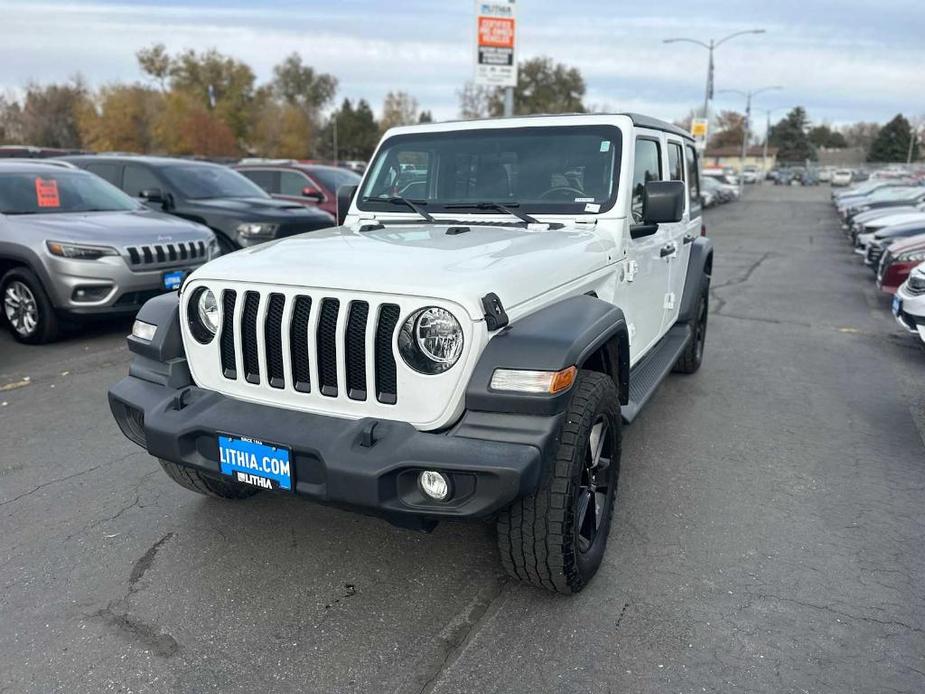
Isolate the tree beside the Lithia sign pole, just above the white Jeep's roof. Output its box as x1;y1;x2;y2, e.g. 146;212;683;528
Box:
488;57;586;116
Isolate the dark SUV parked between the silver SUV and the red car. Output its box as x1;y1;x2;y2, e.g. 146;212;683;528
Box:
64;155;334;253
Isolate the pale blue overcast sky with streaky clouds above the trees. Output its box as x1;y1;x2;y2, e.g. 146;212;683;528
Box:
0;0;925;130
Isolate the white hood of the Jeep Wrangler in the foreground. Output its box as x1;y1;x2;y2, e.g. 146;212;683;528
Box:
193;224;615;319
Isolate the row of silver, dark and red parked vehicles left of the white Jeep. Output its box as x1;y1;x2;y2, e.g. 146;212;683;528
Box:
0;155;360;344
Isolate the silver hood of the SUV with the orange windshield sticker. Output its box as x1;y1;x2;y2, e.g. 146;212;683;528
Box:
3;210;212;245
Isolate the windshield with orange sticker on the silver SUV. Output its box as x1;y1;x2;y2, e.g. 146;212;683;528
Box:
0;168;140;214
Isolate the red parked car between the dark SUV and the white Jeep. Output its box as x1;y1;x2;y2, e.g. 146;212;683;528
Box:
232;160;361;218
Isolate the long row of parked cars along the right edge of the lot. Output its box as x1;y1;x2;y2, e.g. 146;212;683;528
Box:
832;178;925;342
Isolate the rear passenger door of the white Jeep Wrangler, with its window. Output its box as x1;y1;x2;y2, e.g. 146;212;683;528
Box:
663;137;700;331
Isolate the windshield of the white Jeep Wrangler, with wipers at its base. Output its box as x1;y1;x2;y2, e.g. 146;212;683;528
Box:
357;125;621;214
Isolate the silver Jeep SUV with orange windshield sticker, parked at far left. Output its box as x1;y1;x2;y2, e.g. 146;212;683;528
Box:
0;162;217;344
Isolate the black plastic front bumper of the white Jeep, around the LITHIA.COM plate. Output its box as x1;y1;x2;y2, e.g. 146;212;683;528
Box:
109;378;561;524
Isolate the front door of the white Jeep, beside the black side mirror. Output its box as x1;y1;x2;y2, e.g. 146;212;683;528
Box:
622;132;668;363
